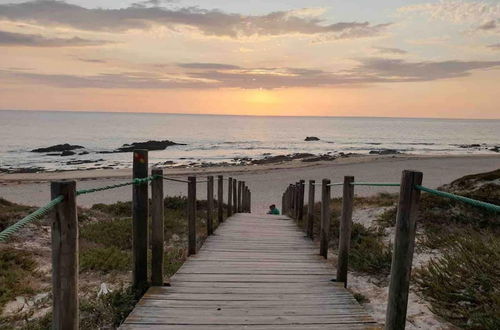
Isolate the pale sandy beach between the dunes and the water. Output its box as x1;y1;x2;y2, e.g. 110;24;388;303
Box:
0;155;500;213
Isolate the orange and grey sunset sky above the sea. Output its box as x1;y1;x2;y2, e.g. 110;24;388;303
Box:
0;0;500;119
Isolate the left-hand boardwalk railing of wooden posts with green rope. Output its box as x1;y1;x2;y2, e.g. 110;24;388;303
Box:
0;149;251;330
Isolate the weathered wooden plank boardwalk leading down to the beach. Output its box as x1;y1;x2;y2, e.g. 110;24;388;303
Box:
121;213;379;330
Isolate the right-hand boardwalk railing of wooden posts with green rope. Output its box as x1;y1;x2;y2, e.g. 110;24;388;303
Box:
282;170;500;330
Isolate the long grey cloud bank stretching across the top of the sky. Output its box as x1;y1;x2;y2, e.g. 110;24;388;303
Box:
0;0;389;39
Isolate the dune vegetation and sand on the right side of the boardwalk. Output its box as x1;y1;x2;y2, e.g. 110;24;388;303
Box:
299;169;500;329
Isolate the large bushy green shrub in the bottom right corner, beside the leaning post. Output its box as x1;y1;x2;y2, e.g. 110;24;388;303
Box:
414;232;500;329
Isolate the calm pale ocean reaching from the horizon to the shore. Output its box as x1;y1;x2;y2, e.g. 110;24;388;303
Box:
0;110;500;171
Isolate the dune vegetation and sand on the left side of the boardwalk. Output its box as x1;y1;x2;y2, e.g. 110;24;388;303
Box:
0;197;225;330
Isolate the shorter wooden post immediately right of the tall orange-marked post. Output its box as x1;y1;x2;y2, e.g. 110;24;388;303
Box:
151;168;165;286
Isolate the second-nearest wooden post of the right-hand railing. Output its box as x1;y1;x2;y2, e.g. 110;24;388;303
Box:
337;176;354;288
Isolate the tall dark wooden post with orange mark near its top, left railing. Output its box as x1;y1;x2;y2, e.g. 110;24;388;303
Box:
132;149;149;296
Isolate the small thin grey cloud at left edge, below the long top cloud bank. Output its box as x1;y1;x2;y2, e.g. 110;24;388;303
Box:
0;31;109;47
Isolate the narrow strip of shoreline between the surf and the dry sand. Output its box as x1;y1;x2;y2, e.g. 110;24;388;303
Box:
0;154;500;186
